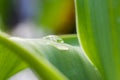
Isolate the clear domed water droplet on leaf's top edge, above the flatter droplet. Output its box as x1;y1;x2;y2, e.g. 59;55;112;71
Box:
43;35;64;43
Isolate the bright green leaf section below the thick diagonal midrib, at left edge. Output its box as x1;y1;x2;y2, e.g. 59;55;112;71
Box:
0;38;27;80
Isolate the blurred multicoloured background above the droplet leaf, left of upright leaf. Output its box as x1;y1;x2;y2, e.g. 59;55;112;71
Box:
0;0;76;38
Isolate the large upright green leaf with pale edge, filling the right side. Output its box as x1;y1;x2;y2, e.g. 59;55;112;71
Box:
76;0;120;80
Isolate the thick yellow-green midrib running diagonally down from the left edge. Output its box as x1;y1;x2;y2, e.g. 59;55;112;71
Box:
0;35;67;80
